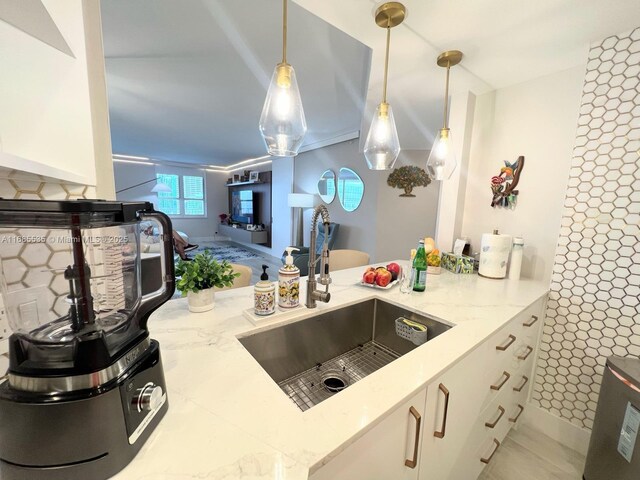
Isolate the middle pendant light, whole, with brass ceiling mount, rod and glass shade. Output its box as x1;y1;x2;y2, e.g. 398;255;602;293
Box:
364;2;406;170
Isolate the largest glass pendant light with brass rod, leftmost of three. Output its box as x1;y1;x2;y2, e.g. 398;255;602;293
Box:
259;0;307;157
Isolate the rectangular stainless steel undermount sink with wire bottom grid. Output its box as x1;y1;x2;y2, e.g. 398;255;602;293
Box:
238;299;451;411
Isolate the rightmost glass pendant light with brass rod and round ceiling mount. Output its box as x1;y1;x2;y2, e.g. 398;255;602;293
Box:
427;50;462;180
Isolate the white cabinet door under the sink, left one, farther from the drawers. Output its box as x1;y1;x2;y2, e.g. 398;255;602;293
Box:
311;390;426;480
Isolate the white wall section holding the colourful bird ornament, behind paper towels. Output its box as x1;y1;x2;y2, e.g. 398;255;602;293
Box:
461;66;584;281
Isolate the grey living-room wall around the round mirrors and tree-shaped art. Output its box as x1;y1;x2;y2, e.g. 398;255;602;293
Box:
294;139;438;263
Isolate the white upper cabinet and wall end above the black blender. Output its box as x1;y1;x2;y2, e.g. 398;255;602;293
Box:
0;0;113;191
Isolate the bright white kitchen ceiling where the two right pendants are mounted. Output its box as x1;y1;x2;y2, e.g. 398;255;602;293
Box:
293;0;640;149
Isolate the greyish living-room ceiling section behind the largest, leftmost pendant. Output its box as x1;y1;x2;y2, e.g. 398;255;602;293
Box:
101;0;371;165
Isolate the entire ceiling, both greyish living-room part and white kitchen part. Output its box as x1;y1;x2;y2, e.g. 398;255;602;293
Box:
102;0;640;165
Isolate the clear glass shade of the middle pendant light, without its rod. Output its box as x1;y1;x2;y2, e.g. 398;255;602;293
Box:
364;102;400;170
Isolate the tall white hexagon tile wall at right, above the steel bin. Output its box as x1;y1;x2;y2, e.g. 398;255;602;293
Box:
533;28;640;429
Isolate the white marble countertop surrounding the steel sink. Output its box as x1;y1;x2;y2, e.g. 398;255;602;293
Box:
113;262;548;480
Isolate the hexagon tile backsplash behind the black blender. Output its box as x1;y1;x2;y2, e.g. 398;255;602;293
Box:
0;167;95;322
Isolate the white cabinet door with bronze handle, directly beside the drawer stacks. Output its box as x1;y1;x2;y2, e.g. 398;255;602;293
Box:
419;342;489;480
